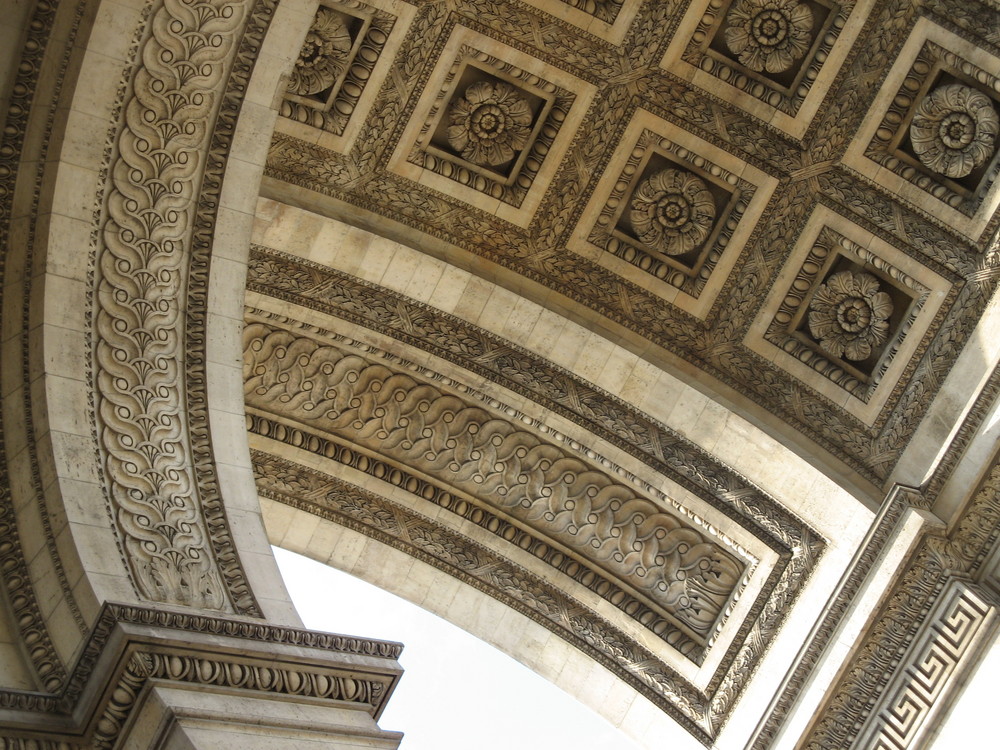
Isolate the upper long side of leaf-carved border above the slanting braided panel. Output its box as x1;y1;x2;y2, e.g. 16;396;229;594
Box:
242;247;824;576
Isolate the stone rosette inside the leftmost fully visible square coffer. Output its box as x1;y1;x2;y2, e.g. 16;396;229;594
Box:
448;81;531;167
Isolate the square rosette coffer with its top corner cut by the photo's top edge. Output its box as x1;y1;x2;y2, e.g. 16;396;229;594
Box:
661;0;871;137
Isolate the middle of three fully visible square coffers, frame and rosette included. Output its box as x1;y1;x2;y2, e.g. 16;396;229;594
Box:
569;110;777;317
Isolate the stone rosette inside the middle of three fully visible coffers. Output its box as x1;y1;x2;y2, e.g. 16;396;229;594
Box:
629;169;715;255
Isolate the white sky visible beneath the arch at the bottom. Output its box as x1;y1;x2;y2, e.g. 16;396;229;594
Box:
274;548;639;750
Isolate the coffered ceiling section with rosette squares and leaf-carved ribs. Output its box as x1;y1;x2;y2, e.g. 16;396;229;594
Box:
265;0;1000;495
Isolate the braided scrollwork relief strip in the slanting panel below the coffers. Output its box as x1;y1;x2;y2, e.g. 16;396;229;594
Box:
244;323;746;639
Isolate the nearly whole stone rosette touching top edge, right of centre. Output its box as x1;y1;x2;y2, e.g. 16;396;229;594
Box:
725;0;813;73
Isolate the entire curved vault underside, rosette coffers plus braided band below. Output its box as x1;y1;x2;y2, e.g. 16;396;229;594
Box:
244;0;1000;744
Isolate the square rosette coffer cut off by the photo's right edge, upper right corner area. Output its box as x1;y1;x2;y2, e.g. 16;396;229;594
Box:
844;19;1000;240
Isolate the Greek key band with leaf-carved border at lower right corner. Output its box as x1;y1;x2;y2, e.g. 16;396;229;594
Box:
801;456;1000;750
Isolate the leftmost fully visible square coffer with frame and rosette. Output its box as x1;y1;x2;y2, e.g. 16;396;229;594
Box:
389;26;595;226
